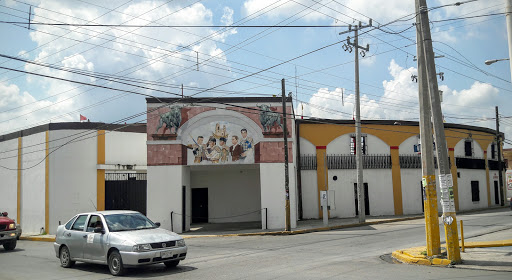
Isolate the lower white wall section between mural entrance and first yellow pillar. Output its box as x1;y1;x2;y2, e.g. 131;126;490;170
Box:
301;170;320;219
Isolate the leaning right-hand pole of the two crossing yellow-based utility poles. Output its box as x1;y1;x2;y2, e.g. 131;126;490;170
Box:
417;0;461;263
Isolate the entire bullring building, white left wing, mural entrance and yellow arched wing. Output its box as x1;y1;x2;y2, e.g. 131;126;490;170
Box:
0;97;512;234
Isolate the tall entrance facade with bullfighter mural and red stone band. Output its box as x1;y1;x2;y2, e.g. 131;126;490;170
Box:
147;97;297;232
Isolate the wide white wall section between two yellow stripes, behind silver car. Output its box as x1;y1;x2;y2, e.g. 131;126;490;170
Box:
49;130;98;234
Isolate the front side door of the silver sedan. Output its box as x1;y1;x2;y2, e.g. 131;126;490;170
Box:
83;215;107;261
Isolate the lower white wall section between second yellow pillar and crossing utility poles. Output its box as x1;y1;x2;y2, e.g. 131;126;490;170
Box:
400;168;423;215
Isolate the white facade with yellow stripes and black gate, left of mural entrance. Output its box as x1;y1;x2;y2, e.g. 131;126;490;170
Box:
0;123;146;234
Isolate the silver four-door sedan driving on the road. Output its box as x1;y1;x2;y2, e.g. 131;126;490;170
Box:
53;210;187;276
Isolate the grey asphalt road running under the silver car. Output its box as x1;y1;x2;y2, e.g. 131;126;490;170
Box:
0;209;512;280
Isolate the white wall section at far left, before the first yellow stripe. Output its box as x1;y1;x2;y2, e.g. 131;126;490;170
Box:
0;138;18;224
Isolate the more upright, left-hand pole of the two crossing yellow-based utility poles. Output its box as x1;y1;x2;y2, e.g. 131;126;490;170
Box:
416;1;441;257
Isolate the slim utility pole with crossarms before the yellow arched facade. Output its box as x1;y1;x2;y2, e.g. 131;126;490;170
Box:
340;19;372;223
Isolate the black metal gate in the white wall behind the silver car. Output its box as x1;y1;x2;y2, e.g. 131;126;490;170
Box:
105;173;147;215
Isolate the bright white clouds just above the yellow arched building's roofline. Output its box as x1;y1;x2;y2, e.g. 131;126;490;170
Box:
297;60;504;135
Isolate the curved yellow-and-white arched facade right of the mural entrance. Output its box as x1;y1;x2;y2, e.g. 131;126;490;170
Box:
297;119;505;219
